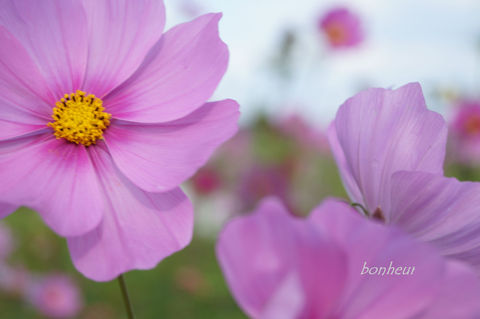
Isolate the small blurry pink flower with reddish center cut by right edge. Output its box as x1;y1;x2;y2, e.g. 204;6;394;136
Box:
449;101;480;165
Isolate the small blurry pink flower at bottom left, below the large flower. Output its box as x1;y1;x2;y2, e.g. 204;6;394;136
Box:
28;275;83;318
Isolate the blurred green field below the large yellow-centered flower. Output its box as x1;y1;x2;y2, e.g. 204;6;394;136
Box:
0;208;246;319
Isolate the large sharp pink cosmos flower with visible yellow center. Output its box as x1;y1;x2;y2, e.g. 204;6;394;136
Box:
0;0;239;281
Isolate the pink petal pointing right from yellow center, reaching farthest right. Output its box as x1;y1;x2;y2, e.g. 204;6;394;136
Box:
105;100;239;192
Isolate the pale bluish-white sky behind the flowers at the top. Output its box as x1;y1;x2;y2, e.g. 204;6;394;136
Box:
165;0;480;124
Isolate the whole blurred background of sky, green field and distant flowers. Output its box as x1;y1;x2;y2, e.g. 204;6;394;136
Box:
0;0;480;319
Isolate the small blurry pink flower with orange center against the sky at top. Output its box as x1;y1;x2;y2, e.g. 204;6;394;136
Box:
318;7;364;49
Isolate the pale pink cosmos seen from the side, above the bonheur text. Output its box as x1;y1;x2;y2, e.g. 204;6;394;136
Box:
329;83;480;270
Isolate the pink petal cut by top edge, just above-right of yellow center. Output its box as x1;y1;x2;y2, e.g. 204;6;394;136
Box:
82;0;165;97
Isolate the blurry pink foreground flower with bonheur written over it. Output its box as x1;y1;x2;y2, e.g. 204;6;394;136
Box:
217;199;480;319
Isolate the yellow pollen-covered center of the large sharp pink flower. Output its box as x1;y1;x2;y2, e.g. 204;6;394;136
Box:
48;91;112;146
